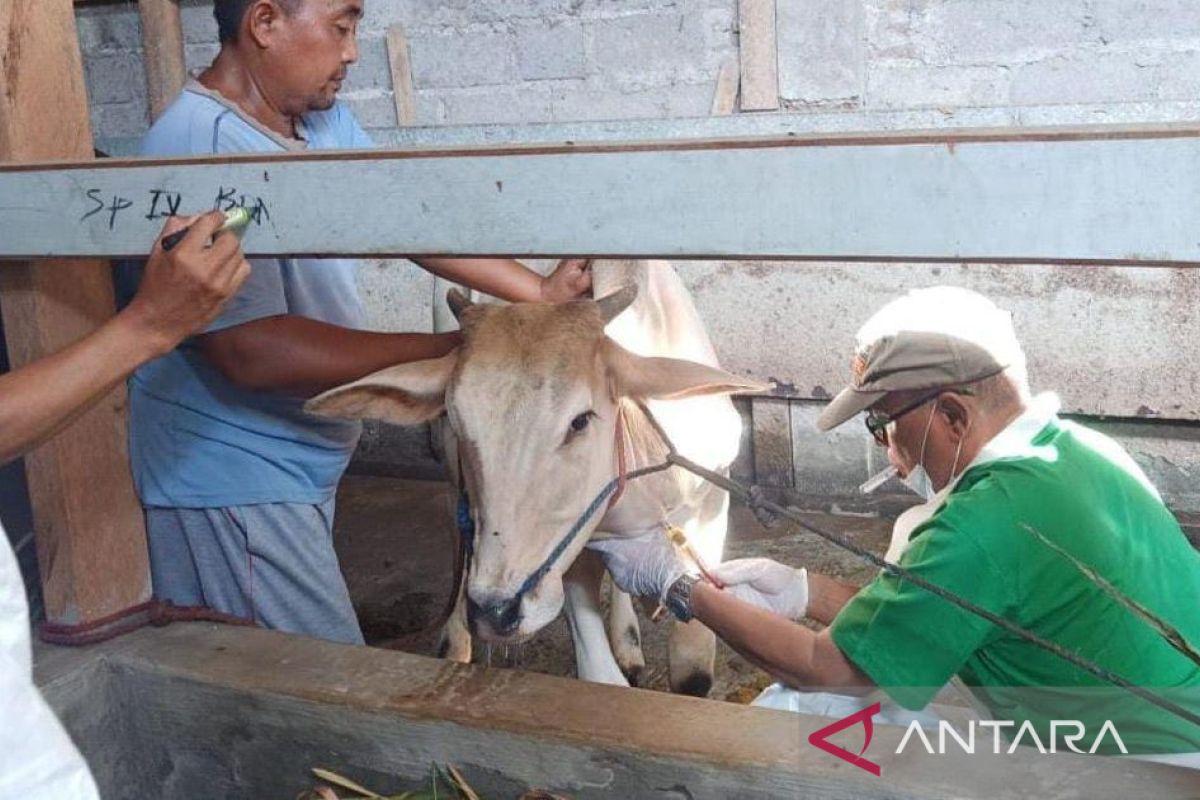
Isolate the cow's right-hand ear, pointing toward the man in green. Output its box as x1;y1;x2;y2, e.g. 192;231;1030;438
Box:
601;337;770;399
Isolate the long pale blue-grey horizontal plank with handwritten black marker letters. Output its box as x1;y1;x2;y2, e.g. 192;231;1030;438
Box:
0;127;1200;265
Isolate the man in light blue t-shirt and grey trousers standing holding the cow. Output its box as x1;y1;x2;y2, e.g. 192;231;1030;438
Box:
130;0;590;643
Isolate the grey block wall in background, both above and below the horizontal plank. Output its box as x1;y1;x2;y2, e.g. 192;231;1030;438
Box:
78;0;1200;520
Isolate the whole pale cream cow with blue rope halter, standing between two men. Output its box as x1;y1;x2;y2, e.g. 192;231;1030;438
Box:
306;260;766;696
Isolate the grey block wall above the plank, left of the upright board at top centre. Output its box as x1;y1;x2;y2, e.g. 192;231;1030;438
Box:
77;0;737;137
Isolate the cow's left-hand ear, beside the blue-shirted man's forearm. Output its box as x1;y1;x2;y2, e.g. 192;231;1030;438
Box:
304;350;458;425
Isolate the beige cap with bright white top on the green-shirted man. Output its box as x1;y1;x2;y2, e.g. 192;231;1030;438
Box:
817;287;1025;431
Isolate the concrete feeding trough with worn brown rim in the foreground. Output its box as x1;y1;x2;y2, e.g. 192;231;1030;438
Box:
37;624;1200;800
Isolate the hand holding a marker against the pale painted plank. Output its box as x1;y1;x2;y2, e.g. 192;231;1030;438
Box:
122;211;250;353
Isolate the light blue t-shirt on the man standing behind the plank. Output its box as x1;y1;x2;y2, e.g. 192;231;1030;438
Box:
130;82;371;507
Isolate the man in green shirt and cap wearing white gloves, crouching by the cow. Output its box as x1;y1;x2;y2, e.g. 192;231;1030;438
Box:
594;288;1200;765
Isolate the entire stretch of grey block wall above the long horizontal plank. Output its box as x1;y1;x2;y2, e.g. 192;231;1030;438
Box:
77;0;1200;137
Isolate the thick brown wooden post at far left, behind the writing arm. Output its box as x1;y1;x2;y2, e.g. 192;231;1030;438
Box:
0;0;150;624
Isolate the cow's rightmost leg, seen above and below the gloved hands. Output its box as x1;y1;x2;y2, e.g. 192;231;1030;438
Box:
667;488;730;697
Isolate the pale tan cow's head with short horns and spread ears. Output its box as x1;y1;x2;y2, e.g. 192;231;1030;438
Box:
306;287;761;640
